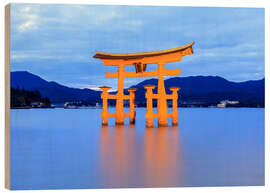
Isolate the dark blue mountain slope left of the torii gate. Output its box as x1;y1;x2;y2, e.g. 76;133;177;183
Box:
10;71;101;104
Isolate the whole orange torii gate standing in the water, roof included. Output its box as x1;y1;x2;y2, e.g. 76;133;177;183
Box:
94;42;194;127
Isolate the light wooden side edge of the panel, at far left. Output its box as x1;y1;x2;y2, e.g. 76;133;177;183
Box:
5;4;10;189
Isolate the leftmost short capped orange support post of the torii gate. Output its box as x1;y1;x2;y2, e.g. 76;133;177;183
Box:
99;86;111;125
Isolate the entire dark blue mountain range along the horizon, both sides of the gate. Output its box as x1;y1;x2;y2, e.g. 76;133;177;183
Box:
11;71;265;106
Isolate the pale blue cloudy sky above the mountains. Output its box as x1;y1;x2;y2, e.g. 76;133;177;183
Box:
10;4;265;89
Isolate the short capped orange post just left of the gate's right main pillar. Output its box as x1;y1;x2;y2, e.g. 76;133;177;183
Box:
144;85;155;127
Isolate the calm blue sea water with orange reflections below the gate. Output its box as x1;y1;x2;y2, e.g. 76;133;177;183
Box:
11;108;264;189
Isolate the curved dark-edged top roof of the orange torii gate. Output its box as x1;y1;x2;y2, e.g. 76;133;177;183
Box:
93;42;194;60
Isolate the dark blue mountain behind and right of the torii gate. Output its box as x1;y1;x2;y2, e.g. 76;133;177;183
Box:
132;76;265;106
